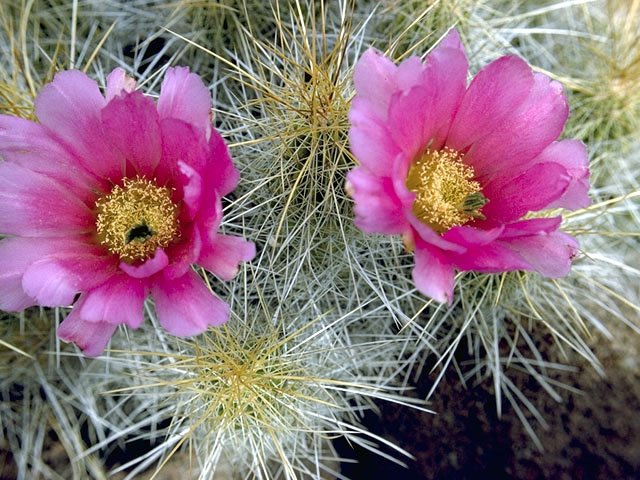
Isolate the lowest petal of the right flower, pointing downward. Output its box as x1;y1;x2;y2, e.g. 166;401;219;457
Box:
412;240;455;305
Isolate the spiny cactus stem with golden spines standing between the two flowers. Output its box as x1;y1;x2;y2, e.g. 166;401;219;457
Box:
220;0;362;271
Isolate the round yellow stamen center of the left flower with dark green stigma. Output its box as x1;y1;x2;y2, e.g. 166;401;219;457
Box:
96;178;179;263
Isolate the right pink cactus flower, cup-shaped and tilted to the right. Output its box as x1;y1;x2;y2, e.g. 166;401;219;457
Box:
347;31;590;304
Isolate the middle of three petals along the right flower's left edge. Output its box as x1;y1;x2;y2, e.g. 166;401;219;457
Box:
349;97;400;177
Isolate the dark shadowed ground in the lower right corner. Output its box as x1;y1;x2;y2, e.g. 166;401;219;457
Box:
336;334;640;480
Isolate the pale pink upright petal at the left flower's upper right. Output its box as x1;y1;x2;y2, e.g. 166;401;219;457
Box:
158;67;212;132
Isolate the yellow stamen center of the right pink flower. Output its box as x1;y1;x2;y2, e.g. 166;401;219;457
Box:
407;148;488;234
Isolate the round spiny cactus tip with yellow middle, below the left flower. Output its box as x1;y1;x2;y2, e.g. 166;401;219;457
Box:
139;322;346;478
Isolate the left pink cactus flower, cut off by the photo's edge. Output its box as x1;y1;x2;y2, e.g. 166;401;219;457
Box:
0;68;255;356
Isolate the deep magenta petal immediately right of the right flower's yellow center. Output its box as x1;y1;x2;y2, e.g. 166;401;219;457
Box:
482;162;571;224
